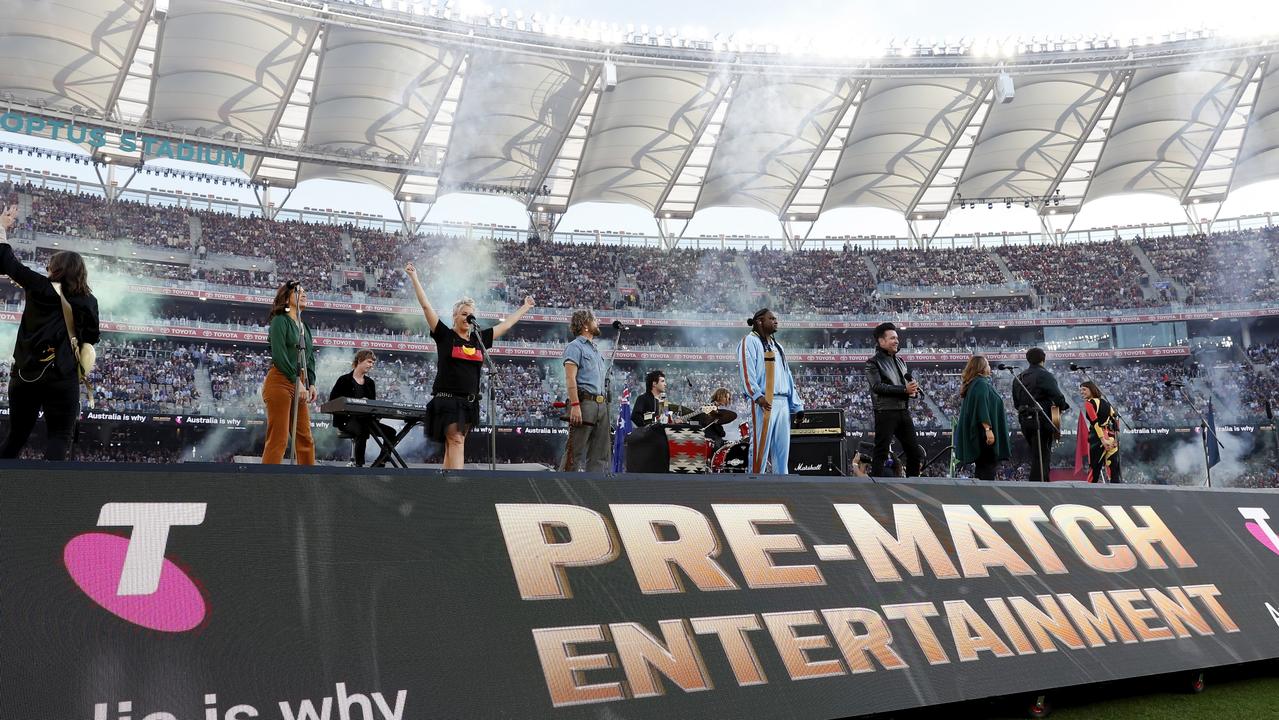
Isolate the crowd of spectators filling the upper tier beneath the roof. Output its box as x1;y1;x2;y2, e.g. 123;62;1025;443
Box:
23;187;1279;315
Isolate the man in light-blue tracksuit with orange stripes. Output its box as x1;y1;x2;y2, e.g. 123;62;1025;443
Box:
738;308;803;474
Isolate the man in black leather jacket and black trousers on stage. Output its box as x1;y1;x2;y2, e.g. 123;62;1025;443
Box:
866;322;923;477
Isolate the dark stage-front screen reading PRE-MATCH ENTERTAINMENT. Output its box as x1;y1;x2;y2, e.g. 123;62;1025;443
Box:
0;463;1279;720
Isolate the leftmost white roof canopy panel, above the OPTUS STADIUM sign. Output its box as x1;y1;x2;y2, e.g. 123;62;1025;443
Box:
0;0;151;114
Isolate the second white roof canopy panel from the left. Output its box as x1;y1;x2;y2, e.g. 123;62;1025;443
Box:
151;0;317;138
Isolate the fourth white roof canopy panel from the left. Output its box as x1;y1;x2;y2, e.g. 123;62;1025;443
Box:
441;51;593;188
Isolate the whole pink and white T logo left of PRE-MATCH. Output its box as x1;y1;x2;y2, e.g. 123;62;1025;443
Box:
63;503;208;633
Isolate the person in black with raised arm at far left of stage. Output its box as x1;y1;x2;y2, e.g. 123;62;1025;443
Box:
0;205;98;460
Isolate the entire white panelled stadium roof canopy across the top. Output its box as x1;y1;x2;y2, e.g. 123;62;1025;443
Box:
0;0;1279;220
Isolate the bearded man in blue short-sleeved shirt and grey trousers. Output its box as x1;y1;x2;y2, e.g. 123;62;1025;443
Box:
560;309;613;472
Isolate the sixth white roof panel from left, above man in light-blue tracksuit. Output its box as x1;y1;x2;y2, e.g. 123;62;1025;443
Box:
697;75;854;215
